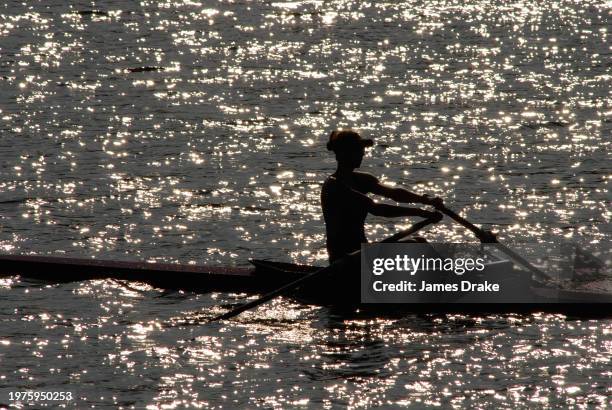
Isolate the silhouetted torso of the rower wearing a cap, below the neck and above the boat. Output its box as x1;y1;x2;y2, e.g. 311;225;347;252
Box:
321;172;376;261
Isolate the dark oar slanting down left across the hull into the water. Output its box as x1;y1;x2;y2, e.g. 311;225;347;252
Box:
209;214;442;323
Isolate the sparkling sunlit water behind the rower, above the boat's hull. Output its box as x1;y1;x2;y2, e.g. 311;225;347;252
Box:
0;1;611;263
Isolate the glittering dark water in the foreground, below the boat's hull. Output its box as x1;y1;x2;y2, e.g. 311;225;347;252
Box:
0;281;610;408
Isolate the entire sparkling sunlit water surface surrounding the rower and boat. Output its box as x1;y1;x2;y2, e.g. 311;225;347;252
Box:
0;0;612;408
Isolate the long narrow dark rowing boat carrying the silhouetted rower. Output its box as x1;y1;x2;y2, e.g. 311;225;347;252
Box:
0;255;612;316
